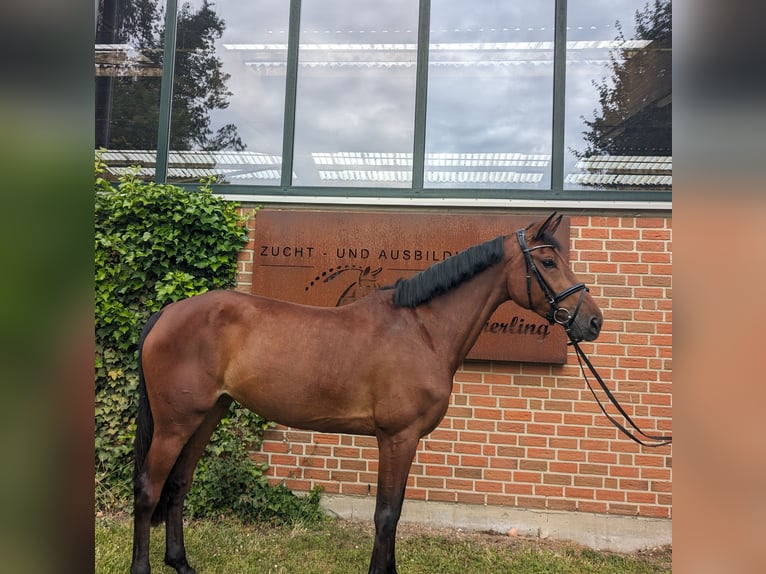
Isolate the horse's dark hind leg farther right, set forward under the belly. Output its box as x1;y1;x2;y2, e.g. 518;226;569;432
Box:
165;396;231;574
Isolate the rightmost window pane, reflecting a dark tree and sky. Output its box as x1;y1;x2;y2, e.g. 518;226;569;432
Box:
564;0;673;194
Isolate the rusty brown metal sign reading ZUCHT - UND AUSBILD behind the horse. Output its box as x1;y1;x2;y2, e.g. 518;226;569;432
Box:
252;209;569;364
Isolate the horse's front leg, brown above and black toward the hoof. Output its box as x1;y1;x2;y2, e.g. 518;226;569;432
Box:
369;434;420;574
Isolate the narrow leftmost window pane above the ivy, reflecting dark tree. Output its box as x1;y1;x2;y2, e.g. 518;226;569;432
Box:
95;0;165;180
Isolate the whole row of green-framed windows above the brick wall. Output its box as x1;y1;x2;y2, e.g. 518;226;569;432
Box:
96;0;672;202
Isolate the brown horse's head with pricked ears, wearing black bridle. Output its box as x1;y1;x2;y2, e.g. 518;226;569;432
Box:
506;213;604;341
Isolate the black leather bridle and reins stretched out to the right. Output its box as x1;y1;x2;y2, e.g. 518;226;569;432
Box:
516;229;673;447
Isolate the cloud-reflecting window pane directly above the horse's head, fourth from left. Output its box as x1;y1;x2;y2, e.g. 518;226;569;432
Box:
424;0;555;189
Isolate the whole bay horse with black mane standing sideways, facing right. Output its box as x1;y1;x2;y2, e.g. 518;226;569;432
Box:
131;213;603;574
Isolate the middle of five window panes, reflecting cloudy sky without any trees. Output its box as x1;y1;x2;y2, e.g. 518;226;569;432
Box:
293;0;418;187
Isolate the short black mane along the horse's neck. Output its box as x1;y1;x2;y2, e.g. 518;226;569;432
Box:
393;235;504;307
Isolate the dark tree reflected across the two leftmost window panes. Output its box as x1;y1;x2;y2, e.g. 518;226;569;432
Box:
96;0;246;151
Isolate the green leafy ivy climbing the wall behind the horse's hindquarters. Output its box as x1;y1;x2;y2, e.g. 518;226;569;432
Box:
95;158;321;520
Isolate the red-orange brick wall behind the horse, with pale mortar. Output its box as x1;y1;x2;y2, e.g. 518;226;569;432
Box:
238;209;672;518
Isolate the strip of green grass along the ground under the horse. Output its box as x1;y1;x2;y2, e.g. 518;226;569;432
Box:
96;517;671;574
